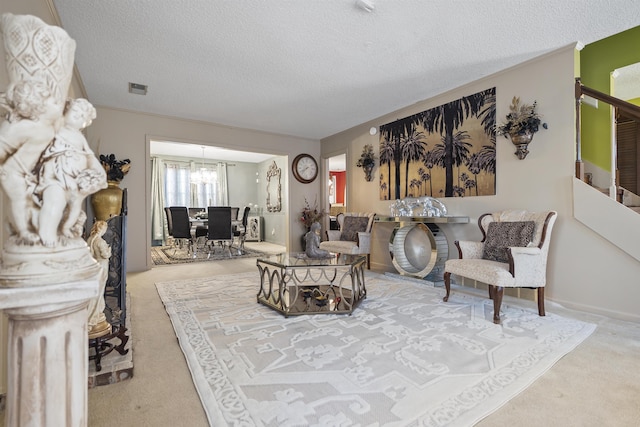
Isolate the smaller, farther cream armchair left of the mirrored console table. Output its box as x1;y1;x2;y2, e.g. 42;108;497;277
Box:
320;212;376;268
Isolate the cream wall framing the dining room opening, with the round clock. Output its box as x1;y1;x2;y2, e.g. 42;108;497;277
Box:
87;106;320;272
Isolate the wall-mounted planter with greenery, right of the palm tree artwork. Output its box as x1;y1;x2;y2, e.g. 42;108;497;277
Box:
498;96;547;160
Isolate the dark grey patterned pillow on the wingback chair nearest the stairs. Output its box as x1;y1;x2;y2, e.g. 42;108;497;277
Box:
482;221;535;262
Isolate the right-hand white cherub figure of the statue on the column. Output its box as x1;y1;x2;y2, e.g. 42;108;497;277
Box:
34;98;107;247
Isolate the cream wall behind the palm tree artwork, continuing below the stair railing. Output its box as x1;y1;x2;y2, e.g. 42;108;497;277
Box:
322;47;640;321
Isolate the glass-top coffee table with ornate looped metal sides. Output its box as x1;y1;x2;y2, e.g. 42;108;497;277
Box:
256;253;367;317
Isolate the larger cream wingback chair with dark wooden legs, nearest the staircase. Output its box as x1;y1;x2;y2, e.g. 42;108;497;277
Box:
444;210;558;324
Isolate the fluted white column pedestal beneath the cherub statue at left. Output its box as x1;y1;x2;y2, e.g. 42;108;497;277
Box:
0;245;100;427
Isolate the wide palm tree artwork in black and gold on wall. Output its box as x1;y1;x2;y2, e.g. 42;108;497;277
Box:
380;87;496;200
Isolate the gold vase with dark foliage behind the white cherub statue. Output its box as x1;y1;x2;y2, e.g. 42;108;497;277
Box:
91;154;131;221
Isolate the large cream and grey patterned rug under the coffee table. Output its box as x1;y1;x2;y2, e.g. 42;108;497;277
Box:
156;271;595;427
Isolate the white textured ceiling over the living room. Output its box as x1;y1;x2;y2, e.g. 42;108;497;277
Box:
53;0;640;139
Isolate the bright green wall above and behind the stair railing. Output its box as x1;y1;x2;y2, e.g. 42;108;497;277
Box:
580;27;640;171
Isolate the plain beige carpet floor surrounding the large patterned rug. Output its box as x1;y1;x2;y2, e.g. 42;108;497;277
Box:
0;243;640;427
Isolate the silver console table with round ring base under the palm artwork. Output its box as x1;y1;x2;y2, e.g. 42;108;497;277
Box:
376;216;469;281
